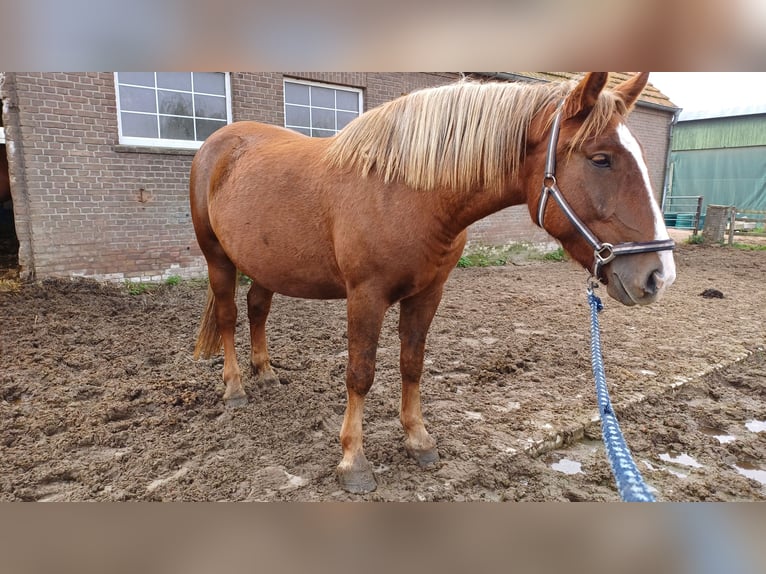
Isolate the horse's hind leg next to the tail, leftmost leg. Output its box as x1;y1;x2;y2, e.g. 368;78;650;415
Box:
208;258;247;407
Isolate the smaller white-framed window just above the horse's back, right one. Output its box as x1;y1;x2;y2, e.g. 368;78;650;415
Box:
284;78;363;137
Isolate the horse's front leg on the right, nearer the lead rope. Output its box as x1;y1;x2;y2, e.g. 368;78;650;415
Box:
399;283;443;467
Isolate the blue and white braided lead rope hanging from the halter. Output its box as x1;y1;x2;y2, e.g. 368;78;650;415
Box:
588;288;654;502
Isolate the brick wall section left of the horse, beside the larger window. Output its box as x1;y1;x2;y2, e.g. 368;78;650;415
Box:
3;73;202;279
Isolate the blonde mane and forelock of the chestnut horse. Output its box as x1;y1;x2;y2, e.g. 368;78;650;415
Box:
326;80;626;195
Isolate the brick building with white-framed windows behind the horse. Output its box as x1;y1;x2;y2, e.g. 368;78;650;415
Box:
0;72;676;281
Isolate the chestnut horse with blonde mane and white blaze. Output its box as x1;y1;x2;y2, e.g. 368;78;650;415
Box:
191;73;675;493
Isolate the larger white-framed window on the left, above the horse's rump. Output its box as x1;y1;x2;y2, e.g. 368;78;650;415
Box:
114;72;231;149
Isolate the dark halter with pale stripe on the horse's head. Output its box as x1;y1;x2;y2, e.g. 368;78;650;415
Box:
537;105;675;282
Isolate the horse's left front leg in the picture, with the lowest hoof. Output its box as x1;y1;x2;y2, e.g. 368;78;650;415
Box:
337;290;388;494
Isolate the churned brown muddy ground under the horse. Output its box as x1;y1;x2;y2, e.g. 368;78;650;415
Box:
0;241;766;501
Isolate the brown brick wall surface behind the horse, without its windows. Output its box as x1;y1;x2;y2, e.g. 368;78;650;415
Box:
3;72;667;280
